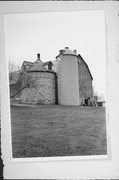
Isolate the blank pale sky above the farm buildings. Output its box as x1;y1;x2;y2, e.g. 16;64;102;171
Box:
4;10;106;100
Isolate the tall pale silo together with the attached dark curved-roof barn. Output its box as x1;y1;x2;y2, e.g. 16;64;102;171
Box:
56;47;93;105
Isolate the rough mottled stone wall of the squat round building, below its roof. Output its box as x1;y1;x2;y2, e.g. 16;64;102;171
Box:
21;72;56;104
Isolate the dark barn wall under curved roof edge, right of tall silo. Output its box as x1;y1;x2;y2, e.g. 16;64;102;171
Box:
78;59;93;99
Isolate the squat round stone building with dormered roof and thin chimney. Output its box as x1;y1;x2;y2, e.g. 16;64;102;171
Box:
10;54;56;104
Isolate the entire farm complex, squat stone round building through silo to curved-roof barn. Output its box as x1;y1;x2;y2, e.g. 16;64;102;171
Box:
10;47;93;105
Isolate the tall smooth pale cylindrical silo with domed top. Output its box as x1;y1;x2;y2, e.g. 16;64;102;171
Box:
56;47;80;105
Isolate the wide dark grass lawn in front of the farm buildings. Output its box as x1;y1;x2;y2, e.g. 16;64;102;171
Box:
11;105;107;158
